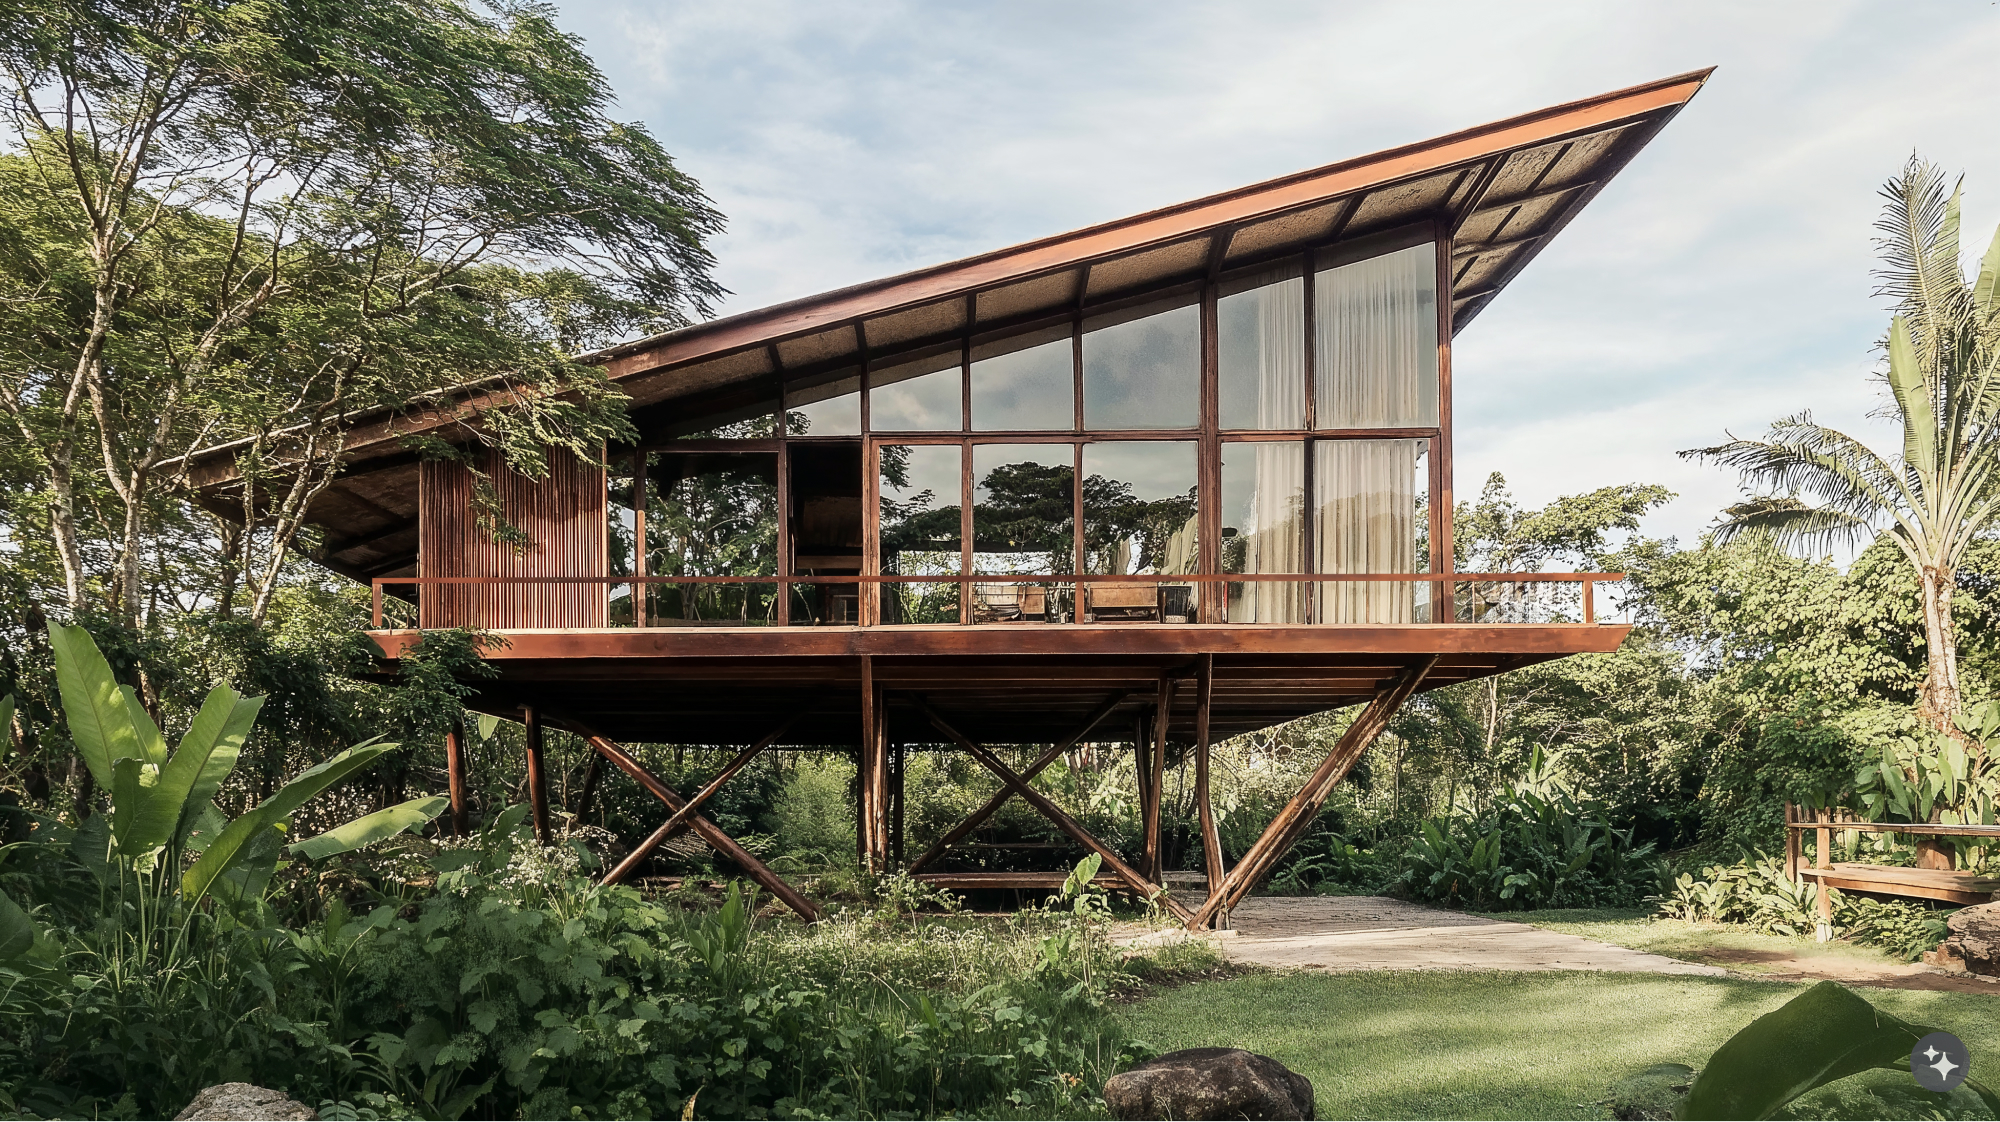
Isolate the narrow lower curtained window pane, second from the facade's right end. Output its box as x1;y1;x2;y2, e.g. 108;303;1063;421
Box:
1222;440;1306;624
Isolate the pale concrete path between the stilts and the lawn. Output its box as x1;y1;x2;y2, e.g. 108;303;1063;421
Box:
1120;896;1728;976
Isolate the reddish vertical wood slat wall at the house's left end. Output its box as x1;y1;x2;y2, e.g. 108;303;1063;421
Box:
418;448;610;630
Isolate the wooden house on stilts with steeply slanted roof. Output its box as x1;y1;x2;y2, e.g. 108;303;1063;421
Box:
190;72;1706;926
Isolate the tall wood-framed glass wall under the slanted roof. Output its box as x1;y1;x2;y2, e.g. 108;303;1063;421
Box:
610;242;1440;626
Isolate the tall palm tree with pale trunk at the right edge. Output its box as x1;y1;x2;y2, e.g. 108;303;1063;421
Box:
1682;156;2000;856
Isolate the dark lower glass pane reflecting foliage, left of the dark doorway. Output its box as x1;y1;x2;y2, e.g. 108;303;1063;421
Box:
646;452;778;626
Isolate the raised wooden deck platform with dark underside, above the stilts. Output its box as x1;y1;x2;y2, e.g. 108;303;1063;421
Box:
370;624;1632;746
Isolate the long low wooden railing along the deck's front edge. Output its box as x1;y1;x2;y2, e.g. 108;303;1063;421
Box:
370;572;1626;630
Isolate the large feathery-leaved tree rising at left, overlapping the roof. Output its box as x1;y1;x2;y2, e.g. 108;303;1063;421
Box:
0;0;720;622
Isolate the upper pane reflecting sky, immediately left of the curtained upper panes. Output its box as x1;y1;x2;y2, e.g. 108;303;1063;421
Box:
1084;304;1202;428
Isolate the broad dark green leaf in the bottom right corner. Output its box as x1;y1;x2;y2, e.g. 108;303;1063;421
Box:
1674;982;2000;1120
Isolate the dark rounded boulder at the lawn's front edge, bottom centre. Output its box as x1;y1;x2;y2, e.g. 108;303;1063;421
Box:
1104;1048;1312;1120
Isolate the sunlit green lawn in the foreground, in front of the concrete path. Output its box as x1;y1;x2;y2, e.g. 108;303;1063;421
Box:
1122;968;2000;1118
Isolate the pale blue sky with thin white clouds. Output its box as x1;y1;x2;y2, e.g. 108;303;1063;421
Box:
558;0;2000;546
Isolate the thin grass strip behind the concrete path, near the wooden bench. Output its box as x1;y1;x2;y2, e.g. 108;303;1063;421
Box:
1480;908;1902;974
